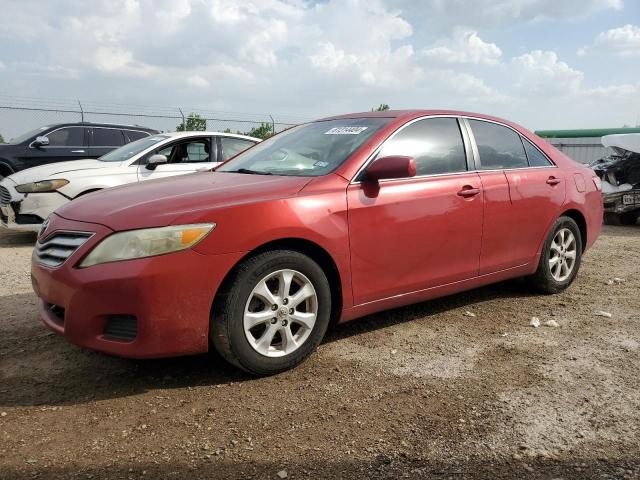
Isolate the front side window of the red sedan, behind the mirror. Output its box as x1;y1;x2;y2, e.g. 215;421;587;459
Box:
378;118;467;175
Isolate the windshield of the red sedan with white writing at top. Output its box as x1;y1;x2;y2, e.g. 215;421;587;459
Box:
216;118;392;177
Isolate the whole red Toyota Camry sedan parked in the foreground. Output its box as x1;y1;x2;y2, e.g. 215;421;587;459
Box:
31;110;602;375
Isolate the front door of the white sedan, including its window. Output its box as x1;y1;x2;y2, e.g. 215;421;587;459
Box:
138;137;217;181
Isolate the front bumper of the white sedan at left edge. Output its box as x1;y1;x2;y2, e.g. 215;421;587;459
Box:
0;179;69;232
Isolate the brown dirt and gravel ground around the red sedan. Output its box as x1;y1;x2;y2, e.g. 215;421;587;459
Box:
0;226;640;479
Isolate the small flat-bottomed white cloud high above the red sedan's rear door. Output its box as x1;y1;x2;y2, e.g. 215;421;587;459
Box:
424;28;502;65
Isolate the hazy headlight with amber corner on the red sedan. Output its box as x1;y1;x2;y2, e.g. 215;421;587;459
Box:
80;223;216;267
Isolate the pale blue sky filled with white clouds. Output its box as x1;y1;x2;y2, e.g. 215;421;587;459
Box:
0;0;640;130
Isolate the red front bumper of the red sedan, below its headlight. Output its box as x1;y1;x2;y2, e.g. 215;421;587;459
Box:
31;214;248;358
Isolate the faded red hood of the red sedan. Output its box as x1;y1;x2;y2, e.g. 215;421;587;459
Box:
55;172;311;231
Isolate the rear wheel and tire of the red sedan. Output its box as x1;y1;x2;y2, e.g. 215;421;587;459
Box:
529;216;582;294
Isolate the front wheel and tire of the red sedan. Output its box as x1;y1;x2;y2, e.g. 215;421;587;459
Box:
209;250;331;375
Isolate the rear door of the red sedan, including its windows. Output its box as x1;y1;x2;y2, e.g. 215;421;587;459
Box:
467;119;565;275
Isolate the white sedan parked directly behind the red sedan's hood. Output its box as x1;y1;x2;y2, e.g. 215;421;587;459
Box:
0;132;260;231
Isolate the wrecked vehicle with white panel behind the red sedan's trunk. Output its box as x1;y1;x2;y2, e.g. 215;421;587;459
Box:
590;133;640;225
